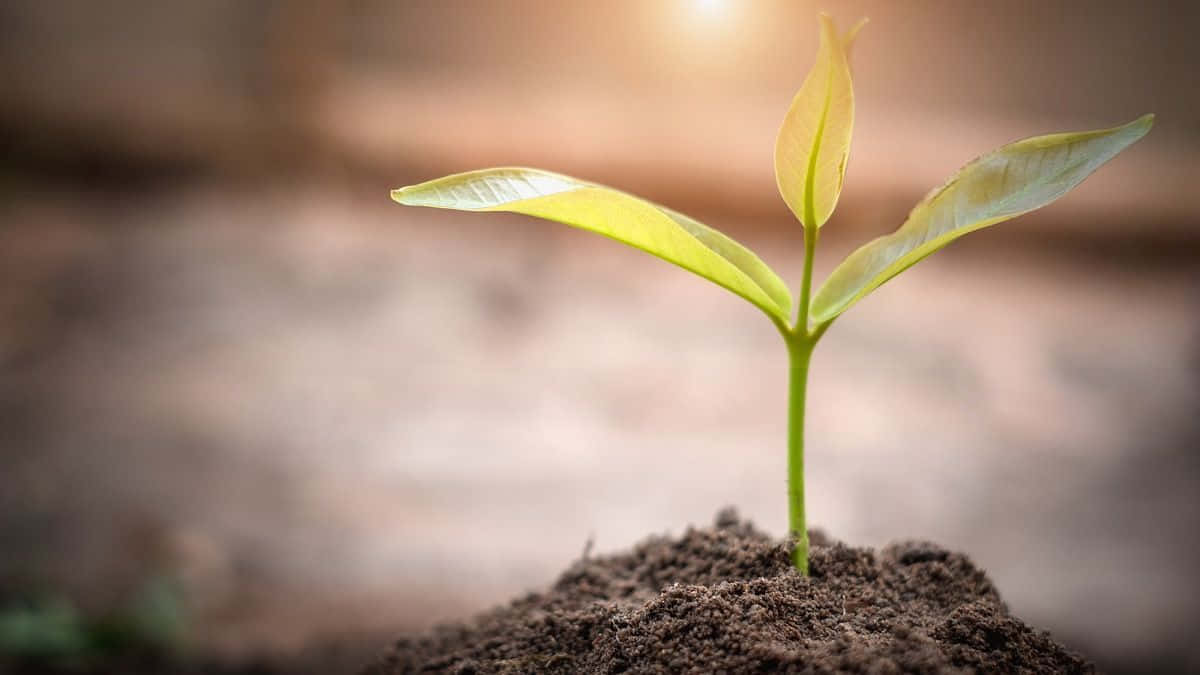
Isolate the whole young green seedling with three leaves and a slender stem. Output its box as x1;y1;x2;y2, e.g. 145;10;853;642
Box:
391;14;1154;574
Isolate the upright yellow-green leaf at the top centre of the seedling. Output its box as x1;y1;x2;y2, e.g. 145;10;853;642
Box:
775;14;865;227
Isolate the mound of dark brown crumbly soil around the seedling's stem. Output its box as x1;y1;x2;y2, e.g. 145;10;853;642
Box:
365;510;1094;675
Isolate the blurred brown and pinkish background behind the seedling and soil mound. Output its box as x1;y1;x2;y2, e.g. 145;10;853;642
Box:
0;0;1200;673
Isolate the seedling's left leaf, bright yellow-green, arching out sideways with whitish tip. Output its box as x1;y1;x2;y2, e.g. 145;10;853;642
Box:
391;168;792;323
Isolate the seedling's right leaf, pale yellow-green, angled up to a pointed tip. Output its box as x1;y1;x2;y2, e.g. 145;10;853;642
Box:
811;114;1154;324
